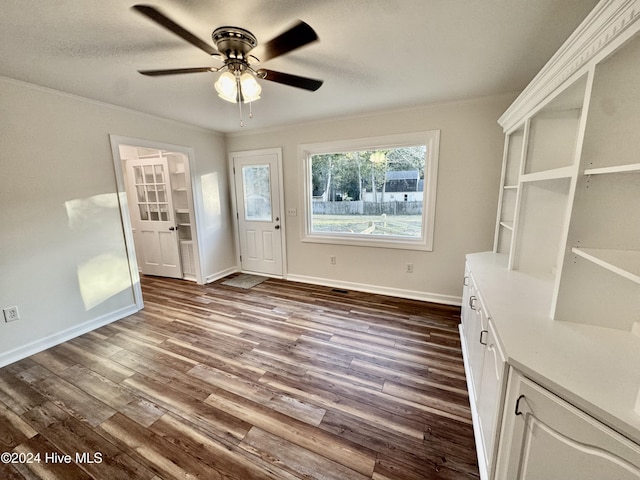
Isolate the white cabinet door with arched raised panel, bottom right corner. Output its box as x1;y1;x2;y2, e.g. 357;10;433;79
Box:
496;371;640;480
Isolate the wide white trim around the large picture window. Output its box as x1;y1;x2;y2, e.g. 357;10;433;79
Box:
298;130;440;251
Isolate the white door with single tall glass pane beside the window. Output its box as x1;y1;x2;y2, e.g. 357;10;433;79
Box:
232;152;283;276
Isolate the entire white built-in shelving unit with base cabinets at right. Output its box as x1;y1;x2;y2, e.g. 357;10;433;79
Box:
460;0;640;480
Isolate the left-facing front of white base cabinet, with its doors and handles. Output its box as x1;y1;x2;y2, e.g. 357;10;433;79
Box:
460;270;506;480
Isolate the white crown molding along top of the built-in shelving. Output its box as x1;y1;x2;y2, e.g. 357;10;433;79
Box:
498;0;640;132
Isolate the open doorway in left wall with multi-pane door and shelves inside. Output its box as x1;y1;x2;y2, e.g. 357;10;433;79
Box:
111;136;201;304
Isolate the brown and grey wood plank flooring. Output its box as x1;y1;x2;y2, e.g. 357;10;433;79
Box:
0;277;479;480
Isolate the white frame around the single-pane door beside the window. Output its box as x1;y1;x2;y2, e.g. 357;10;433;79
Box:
227;147;287;280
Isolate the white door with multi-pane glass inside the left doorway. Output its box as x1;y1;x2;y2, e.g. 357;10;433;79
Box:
127;157;182;278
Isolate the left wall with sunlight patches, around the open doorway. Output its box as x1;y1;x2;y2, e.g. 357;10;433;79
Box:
0;78;235;366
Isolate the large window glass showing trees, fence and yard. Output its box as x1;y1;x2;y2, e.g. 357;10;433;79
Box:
310;145;426;239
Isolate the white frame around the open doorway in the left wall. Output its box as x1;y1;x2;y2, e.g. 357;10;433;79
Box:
109;134;203;309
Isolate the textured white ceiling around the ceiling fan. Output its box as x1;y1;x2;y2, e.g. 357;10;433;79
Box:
0;0;597;132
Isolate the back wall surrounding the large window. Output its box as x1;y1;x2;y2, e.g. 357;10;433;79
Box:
227;94;515;303
